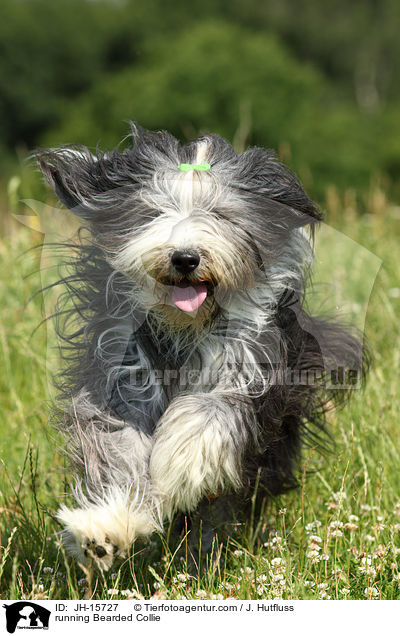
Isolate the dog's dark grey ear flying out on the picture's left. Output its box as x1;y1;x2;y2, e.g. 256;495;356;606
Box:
34;146;118;220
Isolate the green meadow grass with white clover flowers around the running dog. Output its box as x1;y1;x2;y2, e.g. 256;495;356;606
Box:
0;184;400;599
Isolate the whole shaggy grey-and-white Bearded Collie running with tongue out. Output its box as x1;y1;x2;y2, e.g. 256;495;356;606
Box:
38;126;363;570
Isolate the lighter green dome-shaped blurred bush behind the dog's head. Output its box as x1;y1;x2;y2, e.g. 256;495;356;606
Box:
46;21;388;197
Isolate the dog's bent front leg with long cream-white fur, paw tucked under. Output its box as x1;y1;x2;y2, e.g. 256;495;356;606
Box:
150;392;252;516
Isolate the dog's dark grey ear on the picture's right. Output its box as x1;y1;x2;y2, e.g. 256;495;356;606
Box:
239;147;323;228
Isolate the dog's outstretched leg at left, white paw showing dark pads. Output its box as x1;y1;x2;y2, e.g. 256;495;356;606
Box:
58;398;160;570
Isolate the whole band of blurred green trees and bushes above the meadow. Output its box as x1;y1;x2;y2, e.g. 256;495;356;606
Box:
0;0;400;202
